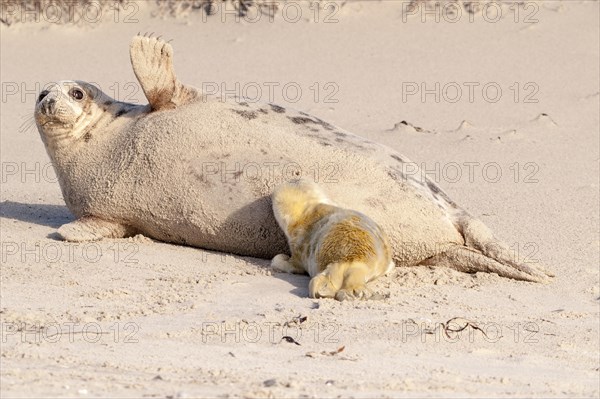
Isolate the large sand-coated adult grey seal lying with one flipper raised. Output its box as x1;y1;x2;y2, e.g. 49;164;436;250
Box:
35;36;550;281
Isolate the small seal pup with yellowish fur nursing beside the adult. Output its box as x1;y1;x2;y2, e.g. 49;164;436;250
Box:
271;180;394;301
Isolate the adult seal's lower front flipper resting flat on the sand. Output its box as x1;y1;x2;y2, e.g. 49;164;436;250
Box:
58;216;136;242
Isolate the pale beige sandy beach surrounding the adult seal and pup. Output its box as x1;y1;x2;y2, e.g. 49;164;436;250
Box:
0;1;600;398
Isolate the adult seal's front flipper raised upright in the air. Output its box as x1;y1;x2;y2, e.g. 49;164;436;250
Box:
129;36;199;111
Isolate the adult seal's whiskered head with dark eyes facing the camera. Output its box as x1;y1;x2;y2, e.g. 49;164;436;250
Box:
35;81;114;148
